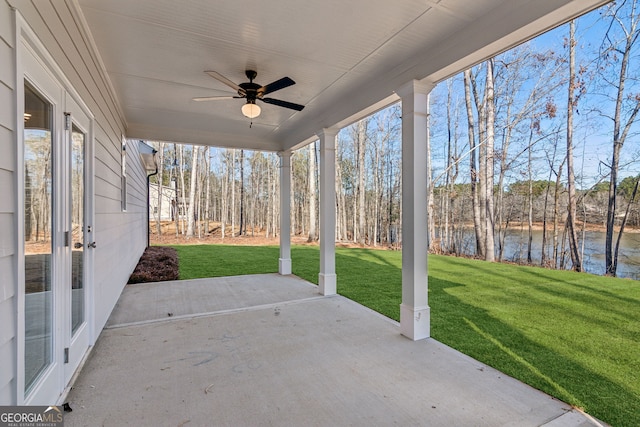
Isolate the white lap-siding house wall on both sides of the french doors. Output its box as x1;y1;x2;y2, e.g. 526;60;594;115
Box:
0;0;147;405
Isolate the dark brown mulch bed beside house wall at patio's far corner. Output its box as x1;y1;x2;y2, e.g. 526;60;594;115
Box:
128;246;179;284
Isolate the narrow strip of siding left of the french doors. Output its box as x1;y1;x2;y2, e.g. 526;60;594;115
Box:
0;1;17;405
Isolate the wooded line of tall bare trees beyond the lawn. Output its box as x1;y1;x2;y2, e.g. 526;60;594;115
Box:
152;0;640;275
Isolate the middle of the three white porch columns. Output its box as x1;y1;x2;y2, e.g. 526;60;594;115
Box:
318;128;338;295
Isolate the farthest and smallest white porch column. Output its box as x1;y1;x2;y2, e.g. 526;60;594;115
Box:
278;151;291;275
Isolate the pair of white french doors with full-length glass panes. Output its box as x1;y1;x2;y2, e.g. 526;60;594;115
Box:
21;45;92;405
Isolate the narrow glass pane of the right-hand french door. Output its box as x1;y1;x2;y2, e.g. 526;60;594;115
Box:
71;124;85;335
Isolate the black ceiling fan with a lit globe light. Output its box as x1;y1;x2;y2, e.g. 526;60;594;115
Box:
193;70;304;119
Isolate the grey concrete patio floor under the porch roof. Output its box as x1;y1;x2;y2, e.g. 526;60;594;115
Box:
65;274;600;427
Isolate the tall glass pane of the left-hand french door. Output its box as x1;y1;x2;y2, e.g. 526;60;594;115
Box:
24;83;53;392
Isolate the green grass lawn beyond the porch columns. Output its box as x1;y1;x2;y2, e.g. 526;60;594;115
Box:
175;245;640;426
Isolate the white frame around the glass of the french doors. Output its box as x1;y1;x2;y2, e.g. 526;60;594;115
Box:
14;10;95;405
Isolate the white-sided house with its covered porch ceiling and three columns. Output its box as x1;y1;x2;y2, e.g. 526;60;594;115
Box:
0;0;606;405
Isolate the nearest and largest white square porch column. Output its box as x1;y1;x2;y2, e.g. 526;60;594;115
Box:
396;80;433;341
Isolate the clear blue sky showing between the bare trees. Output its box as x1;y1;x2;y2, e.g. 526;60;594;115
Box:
424;0;640;189
